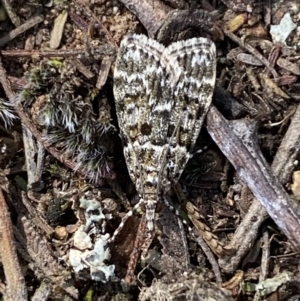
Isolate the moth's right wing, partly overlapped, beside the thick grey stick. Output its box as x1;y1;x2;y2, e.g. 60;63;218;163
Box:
163;38;216;185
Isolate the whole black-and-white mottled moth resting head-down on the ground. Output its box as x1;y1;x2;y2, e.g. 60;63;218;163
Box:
113;34;216;237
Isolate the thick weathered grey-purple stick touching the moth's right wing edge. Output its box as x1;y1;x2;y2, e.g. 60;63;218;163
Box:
206;106;300;250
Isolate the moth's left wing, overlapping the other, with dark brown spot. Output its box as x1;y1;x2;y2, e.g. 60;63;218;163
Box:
114;35;182;197
